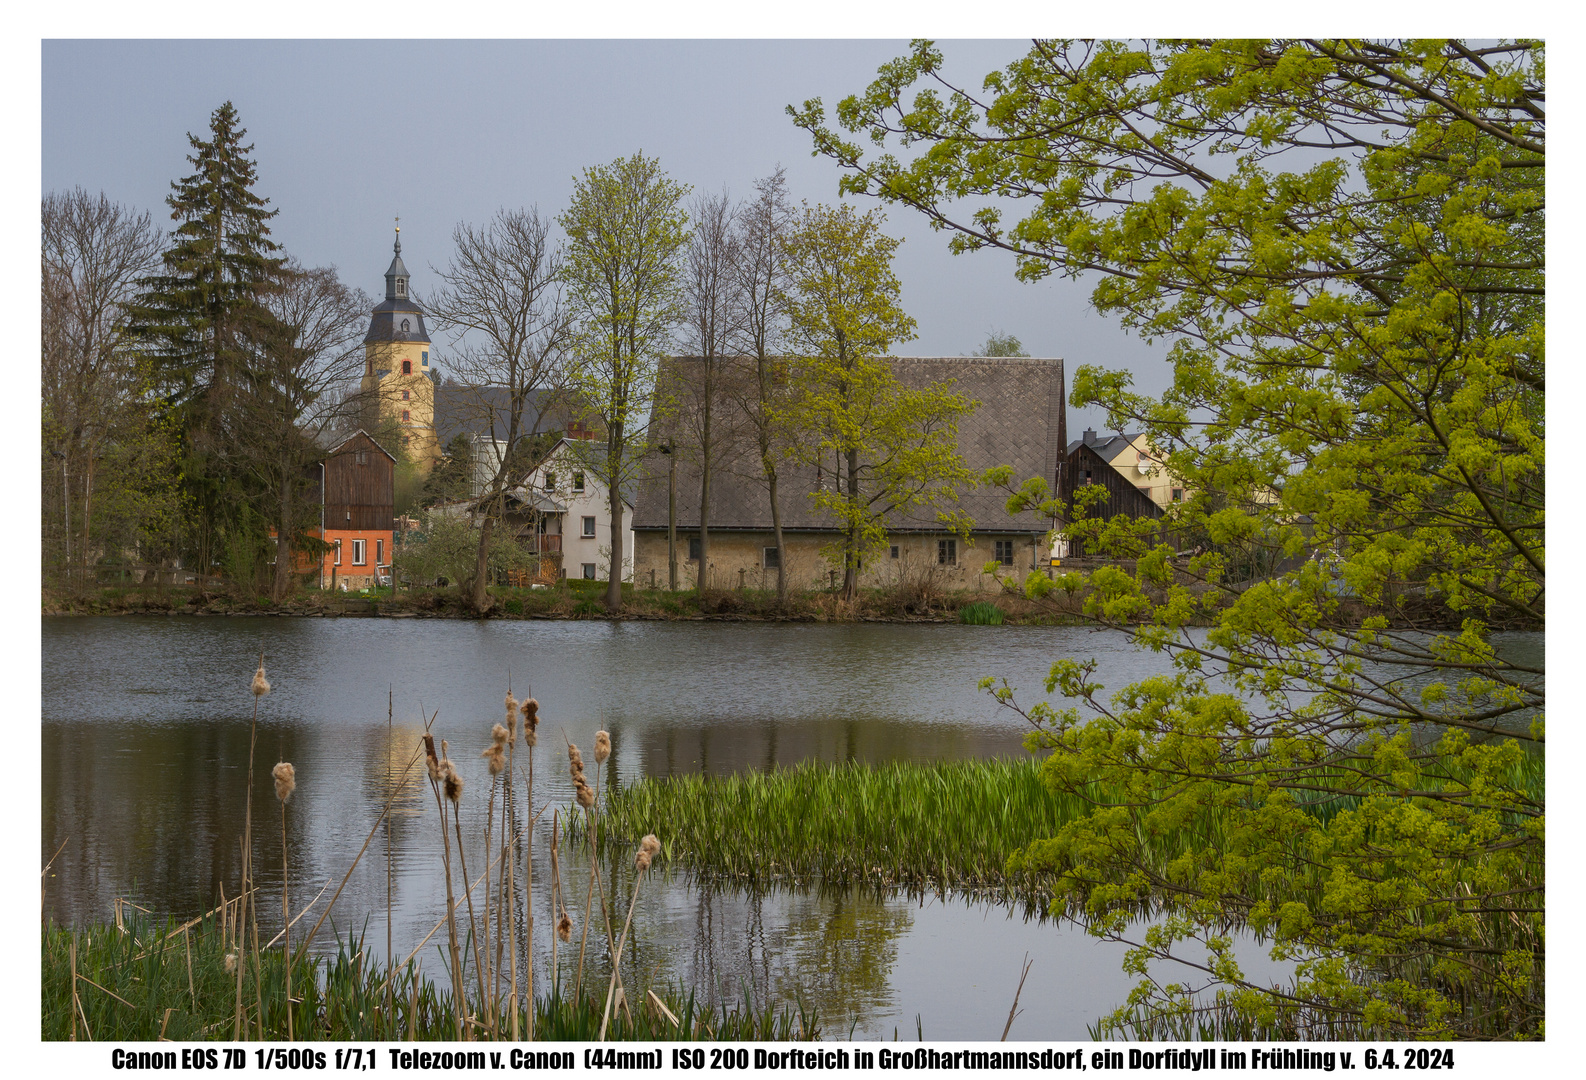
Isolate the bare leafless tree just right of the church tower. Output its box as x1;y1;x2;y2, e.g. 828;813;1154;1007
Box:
428;208;569;611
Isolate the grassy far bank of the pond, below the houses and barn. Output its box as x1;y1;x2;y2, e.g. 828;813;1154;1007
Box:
43;580;1078;625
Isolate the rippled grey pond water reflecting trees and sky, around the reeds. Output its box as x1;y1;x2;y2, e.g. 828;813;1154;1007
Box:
41;617;1363;1039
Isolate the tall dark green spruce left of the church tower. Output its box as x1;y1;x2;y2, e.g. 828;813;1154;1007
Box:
133;101;285;573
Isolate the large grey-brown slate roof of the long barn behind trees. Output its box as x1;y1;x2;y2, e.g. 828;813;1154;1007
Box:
633;357;1067;533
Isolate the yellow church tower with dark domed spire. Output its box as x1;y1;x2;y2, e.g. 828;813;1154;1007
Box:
358;227;439;468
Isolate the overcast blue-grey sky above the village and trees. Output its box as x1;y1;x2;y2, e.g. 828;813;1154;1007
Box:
43;41;1167;433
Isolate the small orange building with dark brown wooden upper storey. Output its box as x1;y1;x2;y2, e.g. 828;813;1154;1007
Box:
309;428;397;588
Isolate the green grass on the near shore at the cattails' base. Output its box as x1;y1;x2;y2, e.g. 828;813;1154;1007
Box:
40;913;820;1042
